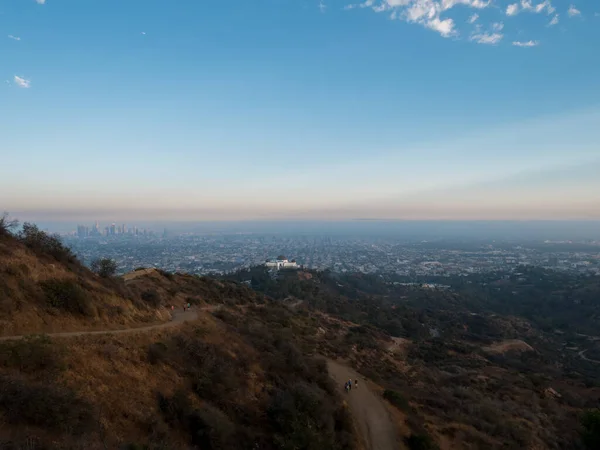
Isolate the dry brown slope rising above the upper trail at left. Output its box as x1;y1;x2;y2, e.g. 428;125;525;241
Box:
0;229;170;336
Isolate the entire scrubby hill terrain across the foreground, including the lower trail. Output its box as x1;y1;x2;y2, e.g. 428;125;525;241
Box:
0;223;600;450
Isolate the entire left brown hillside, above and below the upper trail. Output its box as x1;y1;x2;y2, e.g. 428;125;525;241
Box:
0;227;361;450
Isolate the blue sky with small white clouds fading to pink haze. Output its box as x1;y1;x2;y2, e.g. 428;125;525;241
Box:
0;0;600;220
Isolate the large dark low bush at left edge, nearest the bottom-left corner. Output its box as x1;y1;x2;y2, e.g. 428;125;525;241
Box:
0;376;94;434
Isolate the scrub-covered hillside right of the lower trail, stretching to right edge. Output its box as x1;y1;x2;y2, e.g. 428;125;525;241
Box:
228;267;600;449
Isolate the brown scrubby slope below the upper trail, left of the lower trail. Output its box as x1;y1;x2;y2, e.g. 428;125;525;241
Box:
0;294;357;450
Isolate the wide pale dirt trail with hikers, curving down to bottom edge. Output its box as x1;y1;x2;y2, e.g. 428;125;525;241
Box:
327;360;399;450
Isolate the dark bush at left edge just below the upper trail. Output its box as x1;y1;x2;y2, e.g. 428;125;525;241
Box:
0;336;65;373
